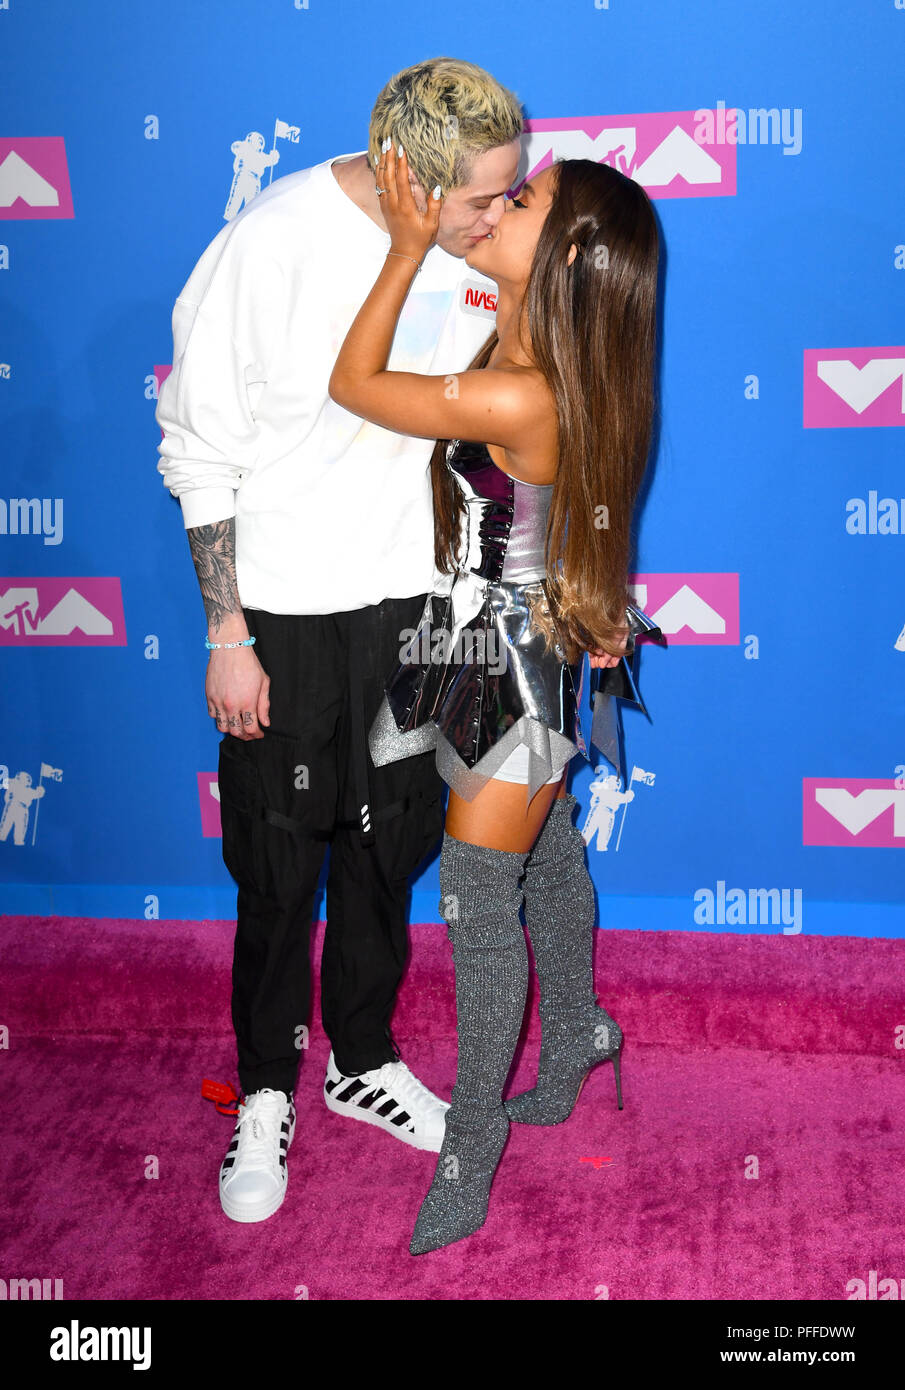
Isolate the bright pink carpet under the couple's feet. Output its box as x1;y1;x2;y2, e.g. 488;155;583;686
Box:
0;917;905;1300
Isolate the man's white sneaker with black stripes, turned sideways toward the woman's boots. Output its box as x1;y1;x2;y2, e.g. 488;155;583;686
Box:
324;1052;449;1154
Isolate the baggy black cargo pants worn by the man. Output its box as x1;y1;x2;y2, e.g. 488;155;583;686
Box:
218;594;443;1095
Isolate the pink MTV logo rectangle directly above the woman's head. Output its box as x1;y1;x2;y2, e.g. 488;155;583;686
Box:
523;111;737;197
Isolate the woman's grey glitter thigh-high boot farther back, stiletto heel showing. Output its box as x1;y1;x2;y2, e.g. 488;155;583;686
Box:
506;794;623;1125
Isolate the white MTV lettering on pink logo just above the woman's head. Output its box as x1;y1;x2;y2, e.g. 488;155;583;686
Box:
523;125;723;188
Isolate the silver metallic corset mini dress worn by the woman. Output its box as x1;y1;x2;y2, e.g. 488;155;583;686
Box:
368;439;665;801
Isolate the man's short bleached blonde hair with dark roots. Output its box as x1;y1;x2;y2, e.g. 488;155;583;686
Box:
368;58;523;196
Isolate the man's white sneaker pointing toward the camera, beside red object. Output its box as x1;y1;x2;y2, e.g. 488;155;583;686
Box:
220;1087;295;1222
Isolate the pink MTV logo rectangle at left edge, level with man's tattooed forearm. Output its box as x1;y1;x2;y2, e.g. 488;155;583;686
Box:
0;575;127;646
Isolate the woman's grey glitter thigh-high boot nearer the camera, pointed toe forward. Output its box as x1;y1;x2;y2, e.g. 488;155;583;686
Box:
409;834;528;1255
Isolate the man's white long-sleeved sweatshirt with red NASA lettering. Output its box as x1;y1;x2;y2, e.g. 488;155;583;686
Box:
156;152;496;613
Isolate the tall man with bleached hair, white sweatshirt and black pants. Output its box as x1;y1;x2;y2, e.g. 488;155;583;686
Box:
157;58;521;1222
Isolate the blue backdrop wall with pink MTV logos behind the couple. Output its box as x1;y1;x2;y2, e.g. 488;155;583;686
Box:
0;0;905;935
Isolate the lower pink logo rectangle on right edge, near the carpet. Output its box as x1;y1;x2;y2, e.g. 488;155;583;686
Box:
802;777;905;849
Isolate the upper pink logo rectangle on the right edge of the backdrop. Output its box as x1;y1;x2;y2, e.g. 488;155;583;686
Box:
805;348;905;430
